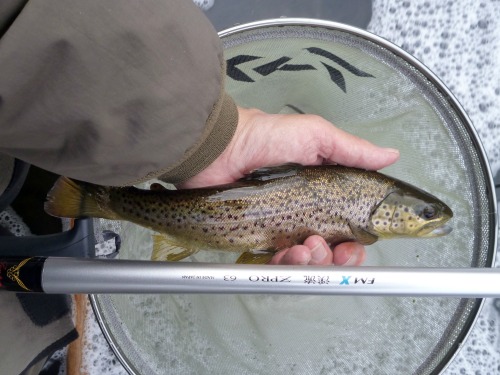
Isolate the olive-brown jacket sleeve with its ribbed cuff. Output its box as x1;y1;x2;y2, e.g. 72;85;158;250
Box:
0;0;237;185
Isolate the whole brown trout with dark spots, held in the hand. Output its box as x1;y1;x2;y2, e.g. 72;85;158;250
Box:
45;164;453;264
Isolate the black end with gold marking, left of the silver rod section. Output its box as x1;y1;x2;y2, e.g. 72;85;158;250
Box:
0;256;47;293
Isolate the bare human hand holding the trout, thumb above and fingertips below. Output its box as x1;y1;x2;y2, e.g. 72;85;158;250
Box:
179;108;399;265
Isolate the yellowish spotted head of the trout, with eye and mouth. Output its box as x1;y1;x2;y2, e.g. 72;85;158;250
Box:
370;185;453;239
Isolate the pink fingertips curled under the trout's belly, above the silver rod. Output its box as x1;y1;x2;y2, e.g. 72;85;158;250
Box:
269;236;366;266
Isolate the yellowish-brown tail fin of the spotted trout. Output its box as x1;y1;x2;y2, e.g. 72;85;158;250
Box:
44;177;118;219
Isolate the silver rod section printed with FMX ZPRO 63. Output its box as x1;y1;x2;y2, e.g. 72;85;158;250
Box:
42;258;500;298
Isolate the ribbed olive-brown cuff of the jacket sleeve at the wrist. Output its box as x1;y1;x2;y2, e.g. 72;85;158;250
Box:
158;92;238;184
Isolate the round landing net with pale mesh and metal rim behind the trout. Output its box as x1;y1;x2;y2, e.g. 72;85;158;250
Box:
90;21;496;374
